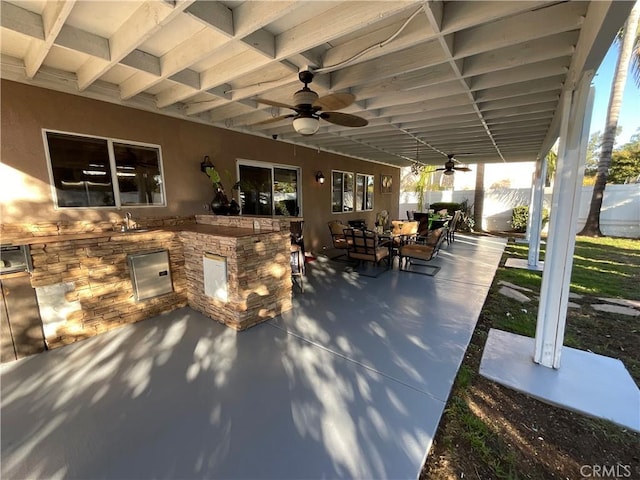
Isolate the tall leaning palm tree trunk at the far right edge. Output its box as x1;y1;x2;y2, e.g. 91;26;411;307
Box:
578;2;640;237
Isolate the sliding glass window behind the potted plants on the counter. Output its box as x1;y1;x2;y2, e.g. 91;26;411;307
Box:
238;161;301;217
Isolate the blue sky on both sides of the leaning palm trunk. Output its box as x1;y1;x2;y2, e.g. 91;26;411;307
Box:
589;42;640;145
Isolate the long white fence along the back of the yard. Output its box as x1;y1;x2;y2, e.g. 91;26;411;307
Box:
400;183;640;238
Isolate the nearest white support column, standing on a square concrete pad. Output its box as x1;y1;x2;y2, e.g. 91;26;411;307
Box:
534;71;594;368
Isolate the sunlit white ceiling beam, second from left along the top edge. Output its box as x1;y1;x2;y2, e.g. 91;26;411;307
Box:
76;0;193;91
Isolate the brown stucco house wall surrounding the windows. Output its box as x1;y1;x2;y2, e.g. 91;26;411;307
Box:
0;80;400;251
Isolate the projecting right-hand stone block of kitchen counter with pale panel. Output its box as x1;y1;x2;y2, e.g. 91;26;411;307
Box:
180;216;292;330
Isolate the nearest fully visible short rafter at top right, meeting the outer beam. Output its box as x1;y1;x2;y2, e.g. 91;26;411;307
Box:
454;2;586;58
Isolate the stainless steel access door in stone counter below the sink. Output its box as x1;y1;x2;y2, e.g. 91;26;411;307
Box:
127;250;173;301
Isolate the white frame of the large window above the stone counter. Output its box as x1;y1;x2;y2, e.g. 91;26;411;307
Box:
42;128;167;210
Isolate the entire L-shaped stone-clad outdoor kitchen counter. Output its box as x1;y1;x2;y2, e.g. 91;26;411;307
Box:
2;215;292;348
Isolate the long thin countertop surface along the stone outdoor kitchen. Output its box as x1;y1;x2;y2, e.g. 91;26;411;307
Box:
1;224;273;245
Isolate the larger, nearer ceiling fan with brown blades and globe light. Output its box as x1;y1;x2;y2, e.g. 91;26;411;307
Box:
253;70;369;135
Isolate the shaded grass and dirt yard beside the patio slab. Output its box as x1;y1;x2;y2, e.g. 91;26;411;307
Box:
421;237;640;479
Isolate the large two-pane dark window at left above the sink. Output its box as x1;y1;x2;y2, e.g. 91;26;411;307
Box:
45;131;165;208
